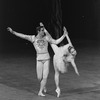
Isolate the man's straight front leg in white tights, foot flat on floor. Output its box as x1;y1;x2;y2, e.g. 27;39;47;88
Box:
38;60;50;96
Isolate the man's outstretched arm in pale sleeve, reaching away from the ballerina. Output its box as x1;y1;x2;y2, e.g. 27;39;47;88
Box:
7;27;35;42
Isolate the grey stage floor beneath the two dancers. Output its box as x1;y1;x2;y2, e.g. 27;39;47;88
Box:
0;44;100;100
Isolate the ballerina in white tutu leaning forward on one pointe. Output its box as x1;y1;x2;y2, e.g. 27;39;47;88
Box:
51;27;79;97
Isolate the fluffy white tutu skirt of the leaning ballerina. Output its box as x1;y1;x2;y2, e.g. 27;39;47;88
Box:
53;55;69;73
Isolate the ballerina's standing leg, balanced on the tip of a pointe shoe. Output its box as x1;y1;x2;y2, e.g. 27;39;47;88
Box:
53;55;60;97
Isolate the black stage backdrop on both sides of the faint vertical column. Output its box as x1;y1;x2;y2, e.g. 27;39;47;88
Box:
0;0;100;53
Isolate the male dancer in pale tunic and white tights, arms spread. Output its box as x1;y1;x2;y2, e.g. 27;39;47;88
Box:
7;23;65;96
